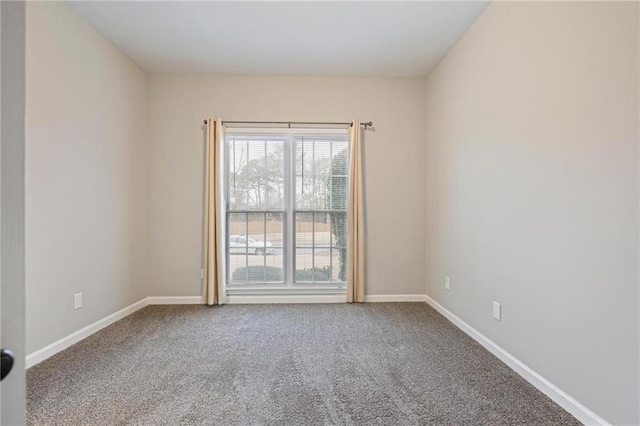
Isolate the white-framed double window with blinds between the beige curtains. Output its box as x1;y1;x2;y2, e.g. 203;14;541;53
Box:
225;129;349;292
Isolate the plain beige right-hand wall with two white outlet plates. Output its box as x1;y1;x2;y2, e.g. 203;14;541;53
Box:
426;2;640;424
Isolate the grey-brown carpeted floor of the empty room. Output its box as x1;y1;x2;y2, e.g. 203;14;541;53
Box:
27;303;579;425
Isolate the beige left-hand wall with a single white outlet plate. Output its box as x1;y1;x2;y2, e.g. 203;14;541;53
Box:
26;2;148;353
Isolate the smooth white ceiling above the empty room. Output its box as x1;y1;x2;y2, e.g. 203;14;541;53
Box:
69;1;488;76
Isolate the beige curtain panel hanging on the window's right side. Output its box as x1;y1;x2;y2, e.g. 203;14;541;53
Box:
347;120;365;303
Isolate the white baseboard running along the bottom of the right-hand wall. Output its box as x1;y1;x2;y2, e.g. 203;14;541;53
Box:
424;295;610;425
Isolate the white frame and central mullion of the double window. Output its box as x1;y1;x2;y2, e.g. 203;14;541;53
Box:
223;127;349;296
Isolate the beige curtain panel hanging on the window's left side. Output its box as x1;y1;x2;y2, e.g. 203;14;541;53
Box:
203;118;224;305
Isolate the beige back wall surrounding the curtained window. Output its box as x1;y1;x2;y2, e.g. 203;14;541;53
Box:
149;75;425;296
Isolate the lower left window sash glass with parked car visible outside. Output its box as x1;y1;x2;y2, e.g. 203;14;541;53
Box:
227;213;284;285
